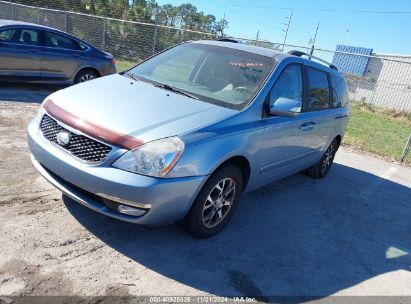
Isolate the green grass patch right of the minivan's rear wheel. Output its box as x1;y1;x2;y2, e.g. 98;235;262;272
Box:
344;102;411;164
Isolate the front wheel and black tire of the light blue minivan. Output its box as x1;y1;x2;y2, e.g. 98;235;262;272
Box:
181;165;243;238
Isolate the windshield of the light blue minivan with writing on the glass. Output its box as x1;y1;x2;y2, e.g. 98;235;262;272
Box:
129;43;275;109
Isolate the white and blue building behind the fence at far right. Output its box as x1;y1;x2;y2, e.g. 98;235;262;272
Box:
333;45;411;112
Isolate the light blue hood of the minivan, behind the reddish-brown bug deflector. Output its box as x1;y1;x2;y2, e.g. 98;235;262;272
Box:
44;74;237;142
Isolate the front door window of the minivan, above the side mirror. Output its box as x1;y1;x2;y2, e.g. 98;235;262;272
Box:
270;65;303;107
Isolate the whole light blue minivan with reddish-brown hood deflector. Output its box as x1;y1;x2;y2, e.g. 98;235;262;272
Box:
28;40;349;237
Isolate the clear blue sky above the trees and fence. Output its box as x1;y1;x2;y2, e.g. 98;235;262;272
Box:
157;0;411;55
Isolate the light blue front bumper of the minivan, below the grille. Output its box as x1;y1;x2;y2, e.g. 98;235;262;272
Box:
27;120;206;225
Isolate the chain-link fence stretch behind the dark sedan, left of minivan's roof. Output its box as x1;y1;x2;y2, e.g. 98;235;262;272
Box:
0;1;216;62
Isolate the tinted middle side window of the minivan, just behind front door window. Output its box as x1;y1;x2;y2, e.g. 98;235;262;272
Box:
306;67;330;111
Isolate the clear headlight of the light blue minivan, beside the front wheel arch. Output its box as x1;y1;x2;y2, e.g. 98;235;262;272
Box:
113;137;184;177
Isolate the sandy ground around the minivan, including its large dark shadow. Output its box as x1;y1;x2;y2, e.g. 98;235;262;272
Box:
0;102;411;303
